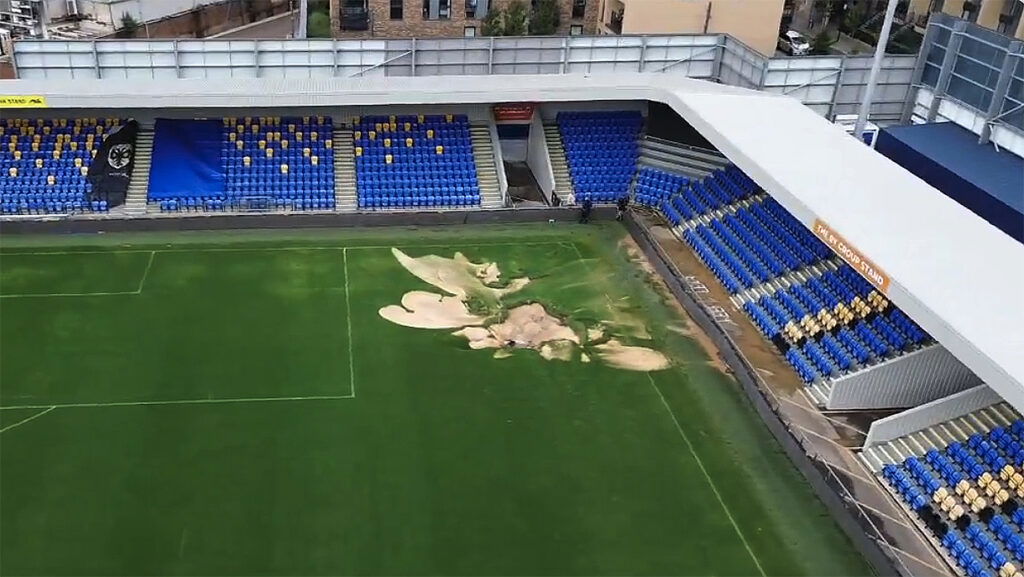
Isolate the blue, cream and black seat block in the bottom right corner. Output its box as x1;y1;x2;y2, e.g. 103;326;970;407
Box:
882;419;1024;577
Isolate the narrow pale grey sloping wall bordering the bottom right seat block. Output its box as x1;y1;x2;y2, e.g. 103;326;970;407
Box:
864;384;1002;449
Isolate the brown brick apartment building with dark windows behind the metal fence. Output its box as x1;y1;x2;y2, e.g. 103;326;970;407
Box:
331;0;601;38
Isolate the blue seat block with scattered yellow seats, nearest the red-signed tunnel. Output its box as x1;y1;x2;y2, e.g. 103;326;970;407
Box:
352;115;480;209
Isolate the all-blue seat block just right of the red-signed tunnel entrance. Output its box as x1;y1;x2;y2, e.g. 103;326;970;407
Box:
556;111;643;203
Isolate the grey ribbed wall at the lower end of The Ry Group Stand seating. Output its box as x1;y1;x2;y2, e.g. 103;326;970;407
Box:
826;344;981;410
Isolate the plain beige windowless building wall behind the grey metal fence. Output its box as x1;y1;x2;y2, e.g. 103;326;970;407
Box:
598;0;792;55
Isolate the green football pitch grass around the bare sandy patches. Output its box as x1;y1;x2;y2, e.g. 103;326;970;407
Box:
0;224;869;575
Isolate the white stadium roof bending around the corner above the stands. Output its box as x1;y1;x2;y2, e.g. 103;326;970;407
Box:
8;74;1024;411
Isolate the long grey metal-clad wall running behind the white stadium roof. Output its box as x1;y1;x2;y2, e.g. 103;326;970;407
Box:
14;34;915;122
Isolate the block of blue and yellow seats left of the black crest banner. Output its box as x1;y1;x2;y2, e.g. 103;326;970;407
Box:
0;118;122;214
